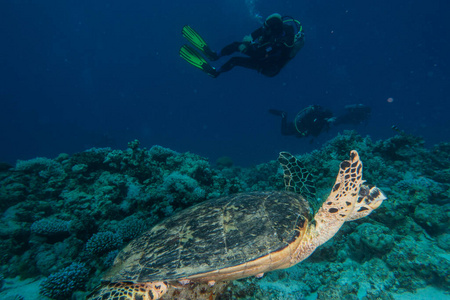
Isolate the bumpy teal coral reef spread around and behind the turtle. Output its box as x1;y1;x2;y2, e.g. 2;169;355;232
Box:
0;131;450;300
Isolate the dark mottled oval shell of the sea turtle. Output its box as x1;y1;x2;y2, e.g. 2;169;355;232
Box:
104;191;311;283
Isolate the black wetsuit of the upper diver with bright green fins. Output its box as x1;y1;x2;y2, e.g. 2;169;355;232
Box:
218;24;295;77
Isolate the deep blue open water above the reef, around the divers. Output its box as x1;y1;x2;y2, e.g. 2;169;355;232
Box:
0;0;450;165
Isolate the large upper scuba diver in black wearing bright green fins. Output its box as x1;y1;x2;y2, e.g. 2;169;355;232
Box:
180;13;304;78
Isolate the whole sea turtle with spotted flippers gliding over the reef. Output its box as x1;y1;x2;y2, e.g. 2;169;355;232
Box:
87;150;386;300
